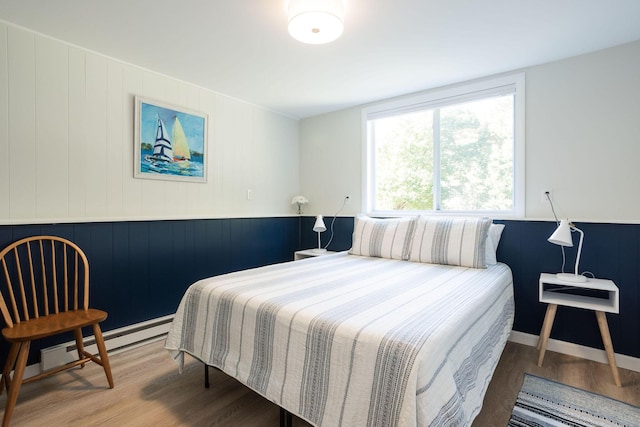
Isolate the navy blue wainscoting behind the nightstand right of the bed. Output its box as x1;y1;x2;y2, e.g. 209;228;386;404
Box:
497;221;640;357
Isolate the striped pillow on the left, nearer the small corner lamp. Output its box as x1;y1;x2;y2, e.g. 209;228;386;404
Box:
349;216;416;260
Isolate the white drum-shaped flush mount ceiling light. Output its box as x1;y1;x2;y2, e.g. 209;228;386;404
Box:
288;0;344;44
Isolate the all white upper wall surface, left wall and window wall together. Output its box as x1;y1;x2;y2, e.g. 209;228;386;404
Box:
5;23;640;224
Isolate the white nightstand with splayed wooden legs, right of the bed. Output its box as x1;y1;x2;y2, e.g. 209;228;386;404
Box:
538;273;621;387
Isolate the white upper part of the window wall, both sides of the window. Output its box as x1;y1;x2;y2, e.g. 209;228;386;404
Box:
300;42;640;223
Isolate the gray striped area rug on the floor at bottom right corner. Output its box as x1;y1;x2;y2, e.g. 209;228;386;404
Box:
509;374;640;427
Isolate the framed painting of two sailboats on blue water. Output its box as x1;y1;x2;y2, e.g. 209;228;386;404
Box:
134;96;207;182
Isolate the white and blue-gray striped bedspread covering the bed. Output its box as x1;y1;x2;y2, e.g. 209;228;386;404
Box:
165;252;514;427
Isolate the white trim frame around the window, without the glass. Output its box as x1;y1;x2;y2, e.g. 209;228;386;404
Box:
361;73;526;219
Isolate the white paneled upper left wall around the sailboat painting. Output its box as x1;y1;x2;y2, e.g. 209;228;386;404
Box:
0;23;299;224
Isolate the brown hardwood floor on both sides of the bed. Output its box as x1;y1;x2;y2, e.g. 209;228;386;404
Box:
0;342;640;427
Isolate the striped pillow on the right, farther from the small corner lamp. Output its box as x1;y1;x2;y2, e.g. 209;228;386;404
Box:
409;216;492;268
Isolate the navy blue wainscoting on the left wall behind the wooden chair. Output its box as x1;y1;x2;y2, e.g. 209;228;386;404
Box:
0;217;302;363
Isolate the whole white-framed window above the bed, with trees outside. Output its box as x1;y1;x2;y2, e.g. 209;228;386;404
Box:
363;74;524;217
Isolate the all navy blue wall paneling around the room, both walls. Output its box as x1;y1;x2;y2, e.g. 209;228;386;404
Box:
0;216;640;363
